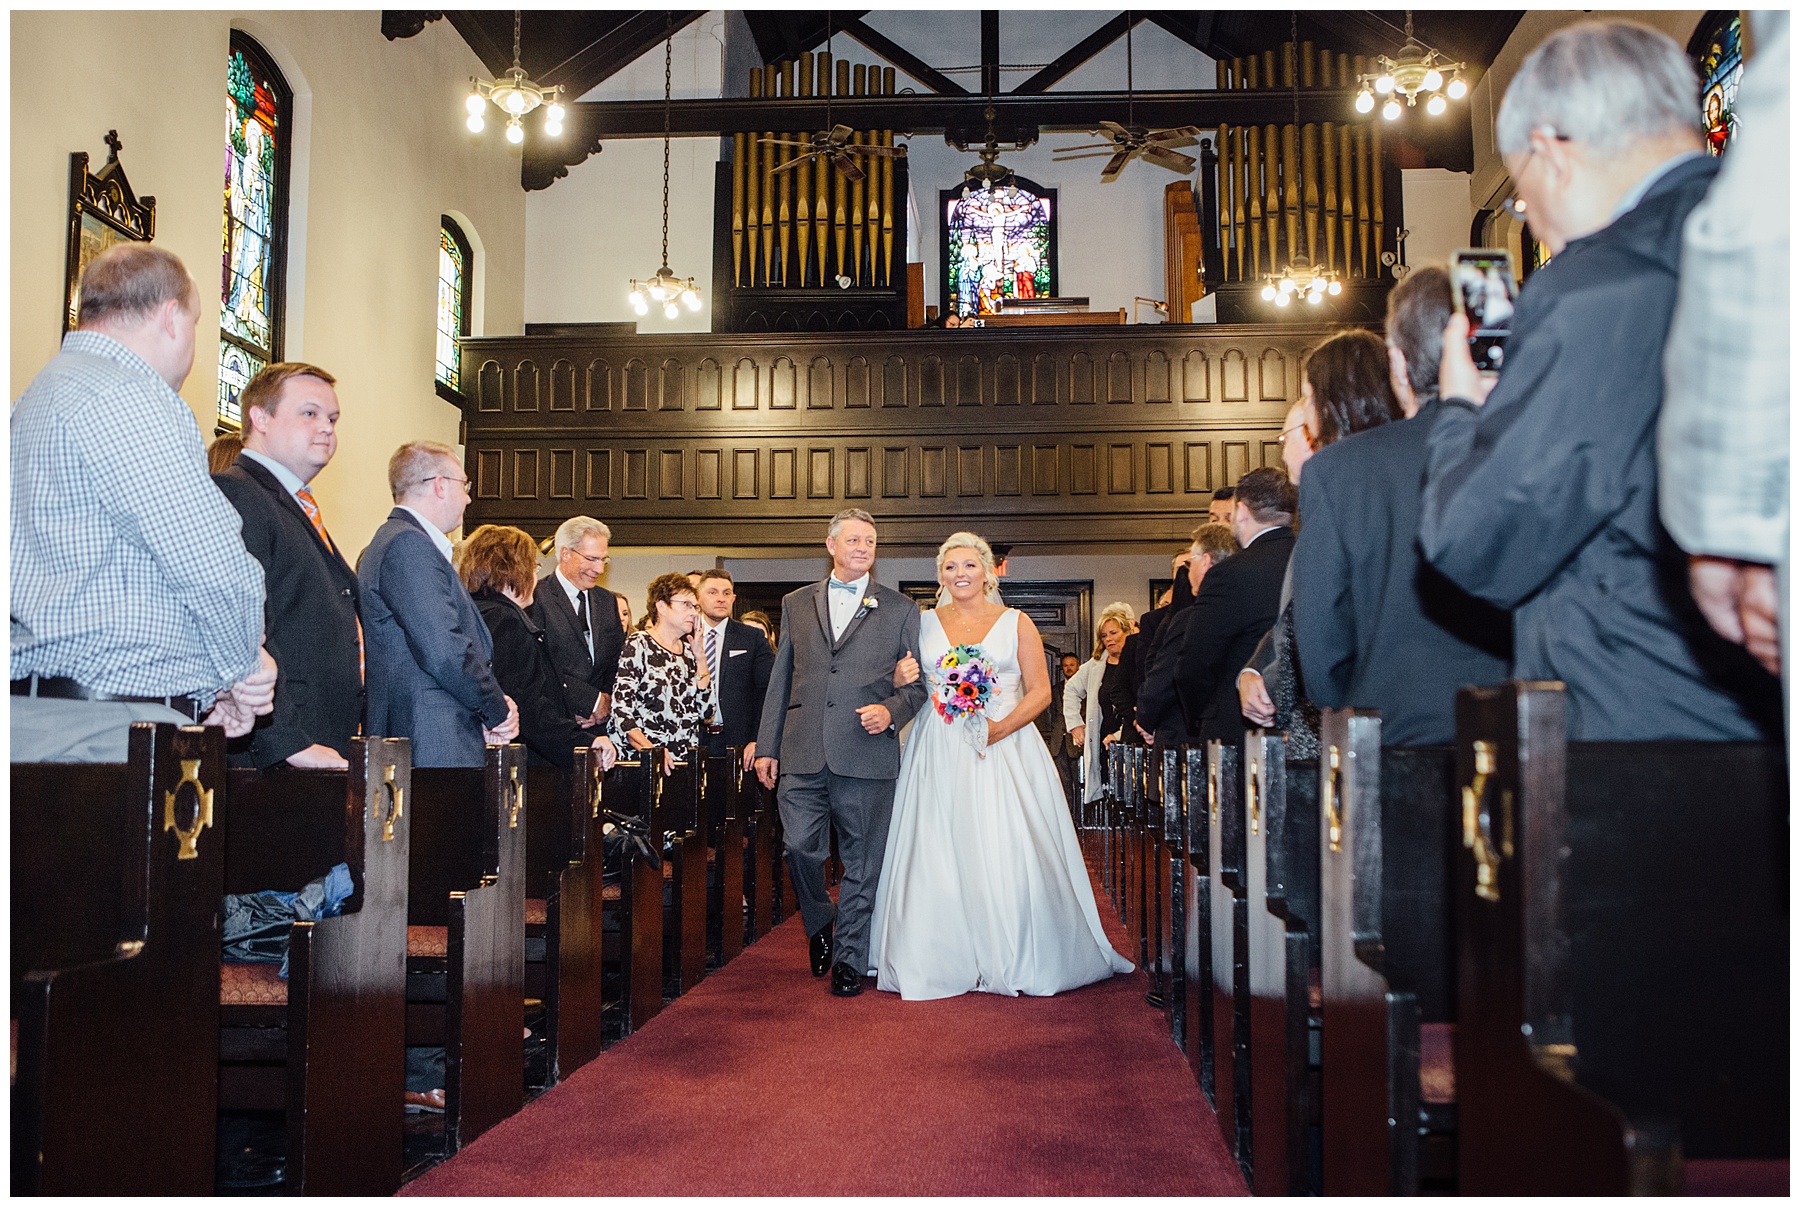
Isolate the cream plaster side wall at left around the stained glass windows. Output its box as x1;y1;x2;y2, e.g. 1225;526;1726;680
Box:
11;9;526;552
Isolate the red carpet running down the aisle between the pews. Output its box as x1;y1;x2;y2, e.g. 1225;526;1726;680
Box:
401;870;1246;1194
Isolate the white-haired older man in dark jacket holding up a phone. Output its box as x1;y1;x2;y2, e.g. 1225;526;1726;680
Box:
1420;22;1780;741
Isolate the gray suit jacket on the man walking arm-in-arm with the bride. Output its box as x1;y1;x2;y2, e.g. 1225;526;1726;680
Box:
756;577;925;779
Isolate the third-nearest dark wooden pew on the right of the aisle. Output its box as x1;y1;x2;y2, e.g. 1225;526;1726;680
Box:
1244;729;1319;1194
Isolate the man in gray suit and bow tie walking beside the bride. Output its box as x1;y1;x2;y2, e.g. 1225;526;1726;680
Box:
756;507;925;997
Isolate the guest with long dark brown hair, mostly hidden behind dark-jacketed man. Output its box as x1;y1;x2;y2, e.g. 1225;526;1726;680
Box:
1238;331;1402;759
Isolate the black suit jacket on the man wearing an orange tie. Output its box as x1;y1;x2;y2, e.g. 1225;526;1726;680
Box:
212;457;362;768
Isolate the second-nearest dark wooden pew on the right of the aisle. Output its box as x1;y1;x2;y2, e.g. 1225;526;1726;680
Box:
1318;711;1454;1194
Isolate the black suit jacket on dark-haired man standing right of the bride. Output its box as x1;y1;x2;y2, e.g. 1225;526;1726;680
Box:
1177;529;1294;741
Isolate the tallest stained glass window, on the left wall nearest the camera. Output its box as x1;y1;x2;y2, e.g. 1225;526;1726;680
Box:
218;31;290;428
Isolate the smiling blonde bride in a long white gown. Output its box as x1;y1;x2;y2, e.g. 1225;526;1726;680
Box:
869;532;1132;1000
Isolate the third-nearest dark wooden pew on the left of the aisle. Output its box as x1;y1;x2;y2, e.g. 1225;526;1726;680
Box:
407;743;527;1153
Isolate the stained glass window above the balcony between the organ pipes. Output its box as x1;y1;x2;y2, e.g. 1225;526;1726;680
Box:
941;176;1057;315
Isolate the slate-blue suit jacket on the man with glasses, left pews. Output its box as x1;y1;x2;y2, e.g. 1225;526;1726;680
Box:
356;507;506;766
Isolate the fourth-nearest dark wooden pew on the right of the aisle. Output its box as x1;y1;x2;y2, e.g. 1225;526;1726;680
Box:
1206;739;1251;1178
